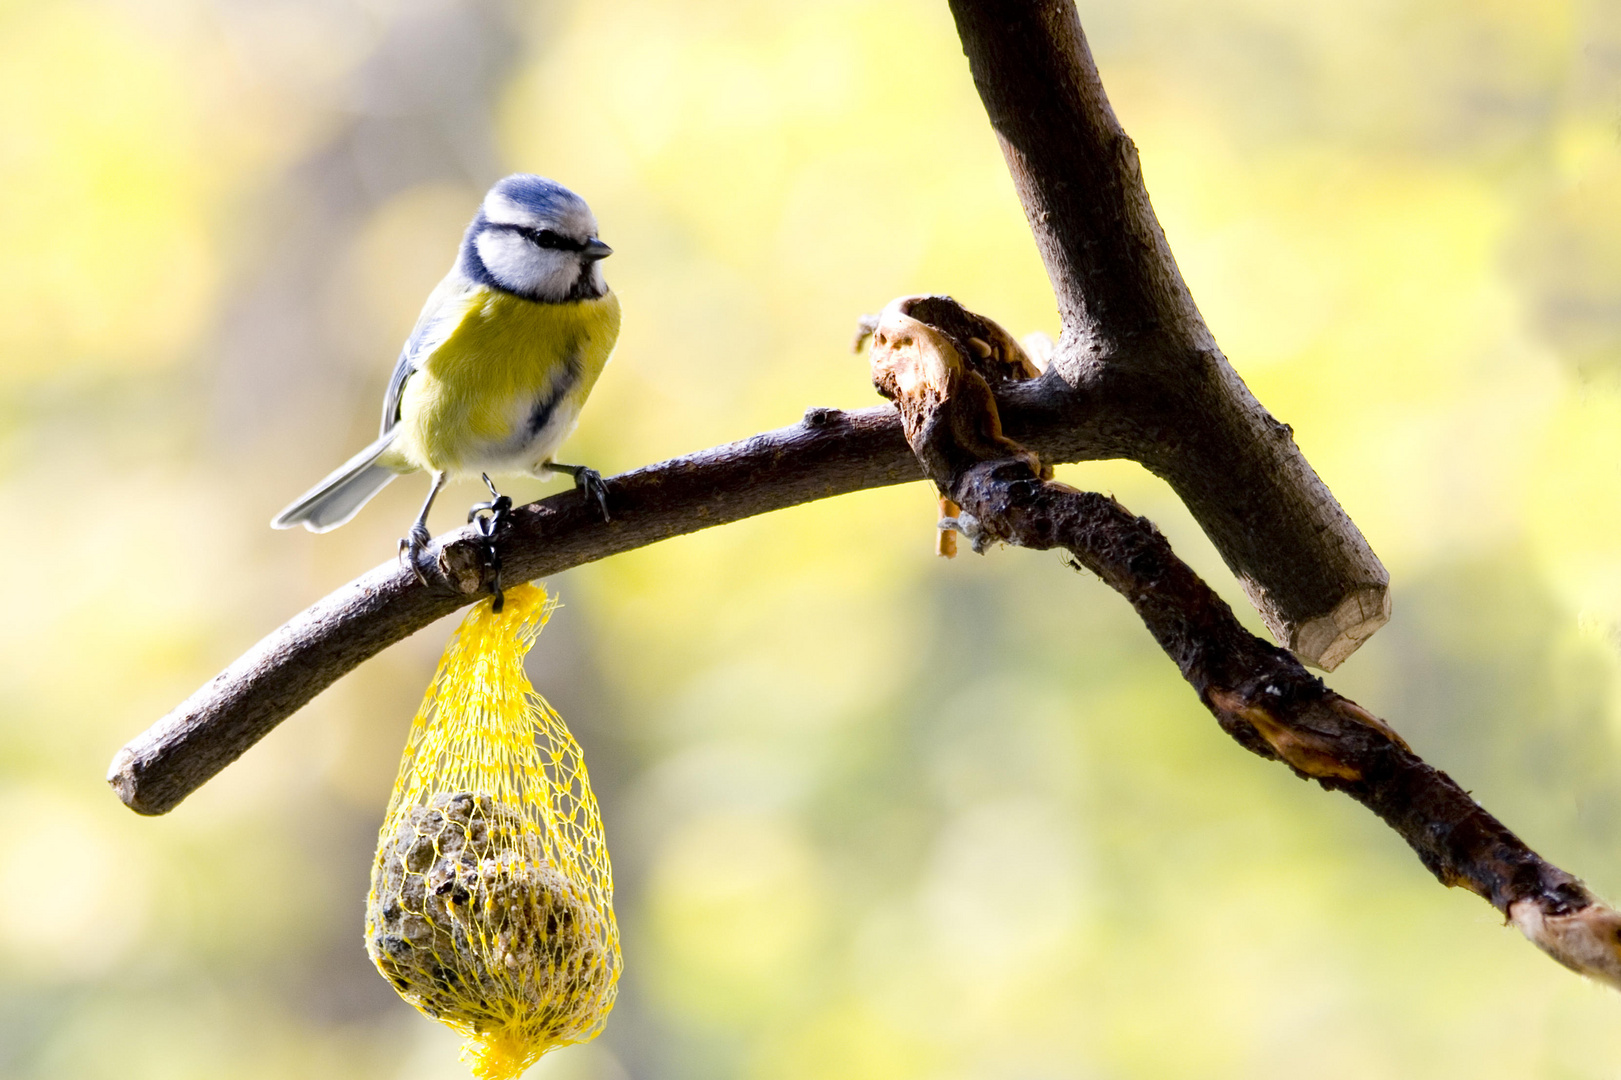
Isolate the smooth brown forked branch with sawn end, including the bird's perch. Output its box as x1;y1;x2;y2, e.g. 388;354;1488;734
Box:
109;0;1389;814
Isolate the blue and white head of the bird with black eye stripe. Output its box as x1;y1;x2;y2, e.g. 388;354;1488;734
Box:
462;172;613;303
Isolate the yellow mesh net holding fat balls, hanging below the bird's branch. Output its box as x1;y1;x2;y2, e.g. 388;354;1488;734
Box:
366;585;619;1080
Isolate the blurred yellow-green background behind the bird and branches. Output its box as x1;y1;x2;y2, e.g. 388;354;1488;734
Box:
0;0;1621;1080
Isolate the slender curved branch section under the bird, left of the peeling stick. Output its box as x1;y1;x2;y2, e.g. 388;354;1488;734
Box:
107;405;921;814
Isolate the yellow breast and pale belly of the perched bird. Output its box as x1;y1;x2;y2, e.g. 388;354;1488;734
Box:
394;289;619;474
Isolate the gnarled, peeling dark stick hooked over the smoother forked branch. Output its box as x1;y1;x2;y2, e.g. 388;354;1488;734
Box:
872;295;1621;989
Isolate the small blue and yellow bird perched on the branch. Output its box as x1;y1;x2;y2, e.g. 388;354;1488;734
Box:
271;172;619;582
